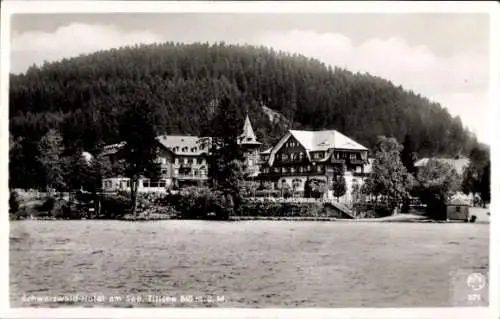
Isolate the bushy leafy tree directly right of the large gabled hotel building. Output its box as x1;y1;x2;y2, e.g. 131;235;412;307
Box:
366;136;412;209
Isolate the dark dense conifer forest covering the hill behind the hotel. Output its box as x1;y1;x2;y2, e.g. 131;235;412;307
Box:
9;43;477;189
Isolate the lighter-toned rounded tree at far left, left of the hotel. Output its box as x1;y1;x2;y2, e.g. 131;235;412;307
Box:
37;129;65;193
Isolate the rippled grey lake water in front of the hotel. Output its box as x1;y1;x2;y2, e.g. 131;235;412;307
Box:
10;220;489;307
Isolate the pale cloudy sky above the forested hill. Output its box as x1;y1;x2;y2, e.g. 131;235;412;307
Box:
11;13;491;143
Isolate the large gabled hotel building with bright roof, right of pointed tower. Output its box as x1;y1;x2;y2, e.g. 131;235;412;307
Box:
259;130;371;200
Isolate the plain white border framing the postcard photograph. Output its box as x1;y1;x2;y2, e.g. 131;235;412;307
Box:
0;0;500;319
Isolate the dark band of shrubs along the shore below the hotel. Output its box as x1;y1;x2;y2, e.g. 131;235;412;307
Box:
9;188;386;221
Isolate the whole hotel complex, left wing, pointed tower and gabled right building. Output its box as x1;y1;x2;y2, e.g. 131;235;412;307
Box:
103;116;371;199
